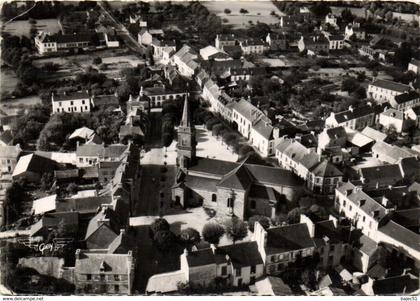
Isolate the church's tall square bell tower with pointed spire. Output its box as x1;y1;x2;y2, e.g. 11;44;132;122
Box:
176;95;197;169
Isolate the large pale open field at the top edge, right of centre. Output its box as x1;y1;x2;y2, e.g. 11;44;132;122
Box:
202;1;284;28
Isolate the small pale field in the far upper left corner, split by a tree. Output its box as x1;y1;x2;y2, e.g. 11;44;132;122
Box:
4;19;60;37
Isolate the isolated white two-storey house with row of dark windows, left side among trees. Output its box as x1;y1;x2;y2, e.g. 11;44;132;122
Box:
51;91;92;114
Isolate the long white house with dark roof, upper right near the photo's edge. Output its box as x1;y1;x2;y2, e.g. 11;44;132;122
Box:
367;80;410;103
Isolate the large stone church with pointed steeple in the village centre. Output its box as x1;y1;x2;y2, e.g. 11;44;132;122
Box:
172;97;302;219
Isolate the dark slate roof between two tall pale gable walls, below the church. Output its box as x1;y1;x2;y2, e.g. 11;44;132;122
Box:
266;223;315;255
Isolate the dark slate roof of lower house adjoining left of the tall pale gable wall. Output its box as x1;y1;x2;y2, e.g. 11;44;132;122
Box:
216;241;263;268
